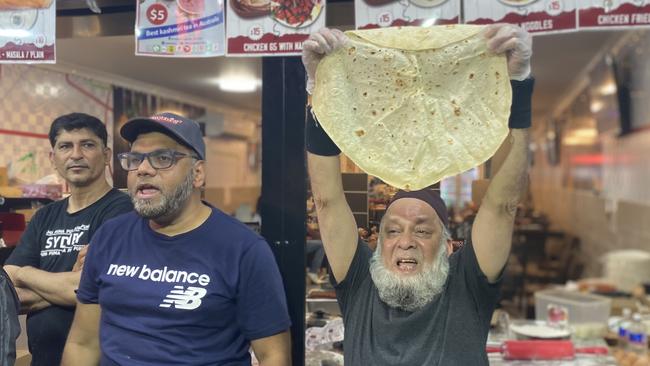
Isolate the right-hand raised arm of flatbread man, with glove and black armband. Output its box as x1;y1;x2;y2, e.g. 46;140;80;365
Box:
472;24;533;282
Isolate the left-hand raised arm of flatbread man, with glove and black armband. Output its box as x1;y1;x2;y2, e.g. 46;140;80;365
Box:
302;28;358;282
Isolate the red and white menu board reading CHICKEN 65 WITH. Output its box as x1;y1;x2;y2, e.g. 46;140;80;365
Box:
226;0;325;56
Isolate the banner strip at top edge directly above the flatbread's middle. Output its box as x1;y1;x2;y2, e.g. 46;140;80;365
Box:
354;0;461;29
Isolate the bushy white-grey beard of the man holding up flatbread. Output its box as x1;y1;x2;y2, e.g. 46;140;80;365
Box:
370;235;449;312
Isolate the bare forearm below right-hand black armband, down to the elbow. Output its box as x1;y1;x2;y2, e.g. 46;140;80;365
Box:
483;128;530;214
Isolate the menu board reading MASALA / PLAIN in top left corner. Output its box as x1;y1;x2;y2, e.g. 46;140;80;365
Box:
0;0;56;64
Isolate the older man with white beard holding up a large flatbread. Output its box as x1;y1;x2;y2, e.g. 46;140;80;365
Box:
303;24;533;366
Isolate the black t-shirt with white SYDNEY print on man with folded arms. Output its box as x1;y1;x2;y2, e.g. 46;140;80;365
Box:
5;189;133;366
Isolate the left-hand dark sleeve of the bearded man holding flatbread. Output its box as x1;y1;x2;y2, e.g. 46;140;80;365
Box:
329;239;373;312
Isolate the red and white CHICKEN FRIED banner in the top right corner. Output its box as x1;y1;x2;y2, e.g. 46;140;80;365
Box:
578;0;650;29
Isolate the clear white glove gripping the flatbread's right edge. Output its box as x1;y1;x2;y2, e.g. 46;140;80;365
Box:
484;24;533;81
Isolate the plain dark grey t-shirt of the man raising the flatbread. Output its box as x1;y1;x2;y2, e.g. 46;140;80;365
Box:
333;240;501;366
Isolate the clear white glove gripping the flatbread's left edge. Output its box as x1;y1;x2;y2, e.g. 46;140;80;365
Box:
302;28;348;94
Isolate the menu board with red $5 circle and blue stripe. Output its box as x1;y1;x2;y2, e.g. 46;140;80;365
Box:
135;0;225;57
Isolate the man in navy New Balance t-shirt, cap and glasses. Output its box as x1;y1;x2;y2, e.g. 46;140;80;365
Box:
63;113;291;366
